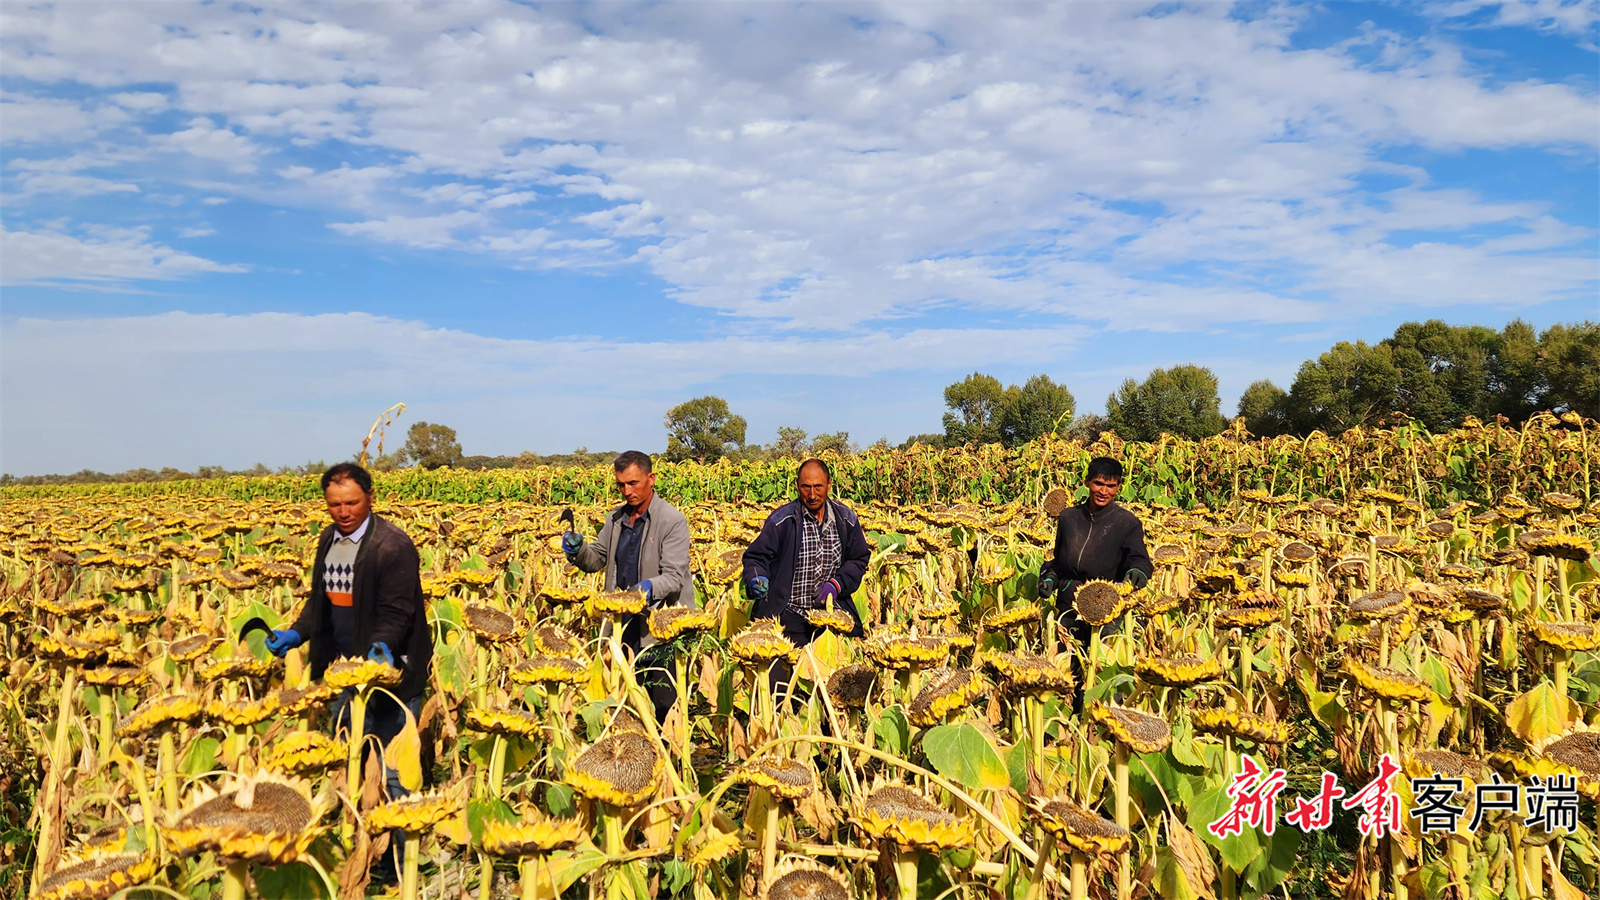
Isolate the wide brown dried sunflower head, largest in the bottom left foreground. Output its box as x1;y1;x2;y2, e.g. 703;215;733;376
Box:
162;762;333;865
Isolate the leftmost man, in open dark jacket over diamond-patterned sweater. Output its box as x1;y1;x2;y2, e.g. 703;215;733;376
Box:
267;463;434;881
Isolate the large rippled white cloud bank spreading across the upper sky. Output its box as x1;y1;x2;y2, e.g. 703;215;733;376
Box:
0;0;1600;331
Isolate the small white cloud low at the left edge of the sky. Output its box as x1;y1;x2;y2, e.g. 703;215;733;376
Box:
0;227;248;287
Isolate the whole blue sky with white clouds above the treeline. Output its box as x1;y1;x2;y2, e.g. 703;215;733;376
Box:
0;0;1600;474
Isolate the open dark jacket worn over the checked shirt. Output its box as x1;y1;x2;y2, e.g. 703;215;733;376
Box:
742;498;872;637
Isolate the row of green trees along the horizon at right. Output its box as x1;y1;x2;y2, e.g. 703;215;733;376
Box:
934;319;1600;447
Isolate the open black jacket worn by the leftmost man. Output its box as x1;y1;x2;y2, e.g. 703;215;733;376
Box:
290;512;434;701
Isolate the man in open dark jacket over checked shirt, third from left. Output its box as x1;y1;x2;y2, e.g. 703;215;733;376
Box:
744;460;872;689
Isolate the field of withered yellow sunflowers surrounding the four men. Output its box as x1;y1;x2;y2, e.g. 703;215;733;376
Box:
0;415;1600;900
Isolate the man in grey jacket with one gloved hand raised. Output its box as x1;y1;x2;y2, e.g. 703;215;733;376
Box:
562;450;694;719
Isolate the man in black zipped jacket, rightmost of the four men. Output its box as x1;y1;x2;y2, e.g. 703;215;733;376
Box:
1038;456;1155;662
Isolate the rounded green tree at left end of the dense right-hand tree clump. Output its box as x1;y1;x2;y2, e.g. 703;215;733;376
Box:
1290;341;1400;434
